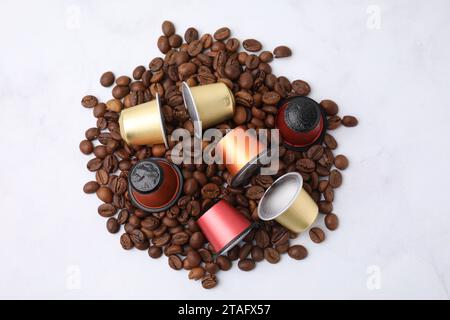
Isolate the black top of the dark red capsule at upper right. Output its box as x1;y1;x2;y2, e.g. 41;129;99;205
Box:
284;97;320;132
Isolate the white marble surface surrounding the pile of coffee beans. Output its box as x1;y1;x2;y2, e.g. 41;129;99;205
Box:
0;0;450;299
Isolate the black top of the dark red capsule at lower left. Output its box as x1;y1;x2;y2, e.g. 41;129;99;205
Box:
129;160;163;193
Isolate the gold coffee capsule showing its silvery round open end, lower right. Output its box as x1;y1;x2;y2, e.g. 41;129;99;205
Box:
258;172;319;233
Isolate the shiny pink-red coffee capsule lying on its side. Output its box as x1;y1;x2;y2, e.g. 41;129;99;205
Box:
197;200;253;255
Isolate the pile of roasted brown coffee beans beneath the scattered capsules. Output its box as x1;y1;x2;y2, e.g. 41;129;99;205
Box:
79;21;358;289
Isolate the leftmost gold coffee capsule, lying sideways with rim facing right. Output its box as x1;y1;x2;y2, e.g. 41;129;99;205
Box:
119;95;169;148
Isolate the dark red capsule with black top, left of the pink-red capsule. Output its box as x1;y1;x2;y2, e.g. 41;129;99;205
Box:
128;158;183;212
